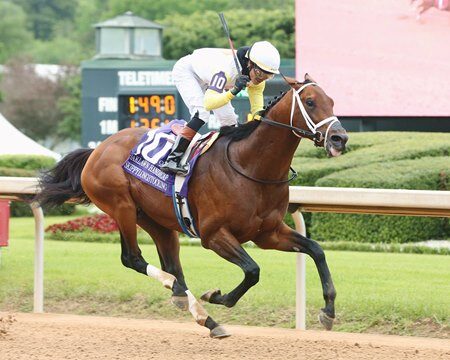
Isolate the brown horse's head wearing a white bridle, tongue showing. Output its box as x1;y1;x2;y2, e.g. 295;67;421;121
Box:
278;74;348;156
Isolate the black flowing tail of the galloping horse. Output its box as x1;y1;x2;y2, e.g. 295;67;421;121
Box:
34;149;94;208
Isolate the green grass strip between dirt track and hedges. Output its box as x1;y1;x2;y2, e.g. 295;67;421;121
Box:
0;217;450;338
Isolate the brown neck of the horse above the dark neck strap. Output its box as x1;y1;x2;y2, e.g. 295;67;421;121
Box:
234;109;300;180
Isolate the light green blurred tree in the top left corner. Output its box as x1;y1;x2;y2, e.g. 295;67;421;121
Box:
0;1;32;64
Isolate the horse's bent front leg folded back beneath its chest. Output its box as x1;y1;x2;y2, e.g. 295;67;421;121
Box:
201;229;259;307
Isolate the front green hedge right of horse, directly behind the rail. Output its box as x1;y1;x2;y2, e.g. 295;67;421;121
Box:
310;156;450;243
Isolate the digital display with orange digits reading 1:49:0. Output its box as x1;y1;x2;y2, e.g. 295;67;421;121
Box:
119;94;177;128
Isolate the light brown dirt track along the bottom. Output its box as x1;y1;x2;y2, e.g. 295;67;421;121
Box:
0;313;450;360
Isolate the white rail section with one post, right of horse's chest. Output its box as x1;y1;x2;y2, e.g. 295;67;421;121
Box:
289;186;450;330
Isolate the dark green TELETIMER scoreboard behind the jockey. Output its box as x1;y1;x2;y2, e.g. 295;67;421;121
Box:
81;59;295;148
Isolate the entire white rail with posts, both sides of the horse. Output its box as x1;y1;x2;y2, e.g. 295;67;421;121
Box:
0;177;450;329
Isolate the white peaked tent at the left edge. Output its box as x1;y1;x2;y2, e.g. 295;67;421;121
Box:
0;113;61;160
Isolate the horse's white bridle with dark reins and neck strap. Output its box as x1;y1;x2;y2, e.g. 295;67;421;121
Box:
225;80;339;185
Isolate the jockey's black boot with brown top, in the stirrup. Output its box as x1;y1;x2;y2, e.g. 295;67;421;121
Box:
161;112;205;175
